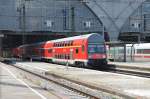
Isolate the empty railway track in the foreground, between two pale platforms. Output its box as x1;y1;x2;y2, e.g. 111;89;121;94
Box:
3;61;119;99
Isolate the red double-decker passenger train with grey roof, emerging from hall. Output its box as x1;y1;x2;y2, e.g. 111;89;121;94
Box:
13;33;107;66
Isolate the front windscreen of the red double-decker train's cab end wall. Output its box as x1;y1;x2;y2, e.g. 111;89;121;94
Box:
88;44;105;53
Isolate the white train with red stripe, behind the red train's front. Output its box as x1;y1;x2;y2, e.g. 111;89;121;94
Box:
108;43;150;62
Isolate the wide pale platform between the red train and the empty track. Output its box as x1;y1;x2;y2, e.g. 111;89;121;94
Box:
14;62;150;99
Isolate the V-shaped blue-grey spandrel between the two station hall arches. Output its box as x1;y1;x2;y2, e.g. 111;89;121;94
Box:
85;0;146;41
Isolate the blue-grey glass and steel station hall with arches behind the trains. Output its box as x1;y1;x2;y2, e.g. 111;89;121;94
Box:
0;0;150;61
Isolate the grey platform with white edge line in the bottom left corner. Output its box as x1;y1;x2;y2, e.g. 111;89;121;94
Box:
0;63;61;99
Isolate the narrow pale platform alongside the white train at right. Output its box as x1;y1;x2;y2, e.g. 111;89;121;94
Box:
108;62;150;72
